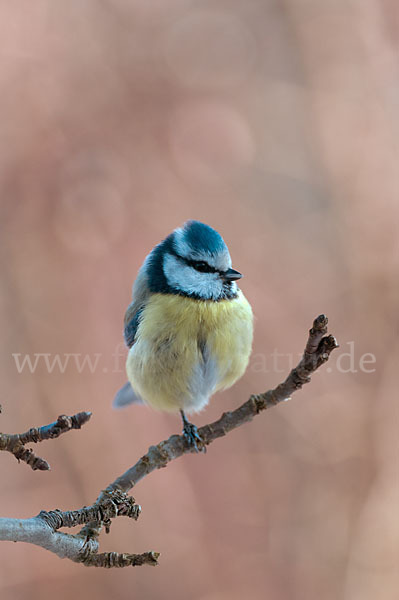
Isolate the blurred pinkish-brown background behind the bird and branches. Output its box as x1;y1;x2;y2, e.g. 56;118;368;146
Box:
0;0;399;600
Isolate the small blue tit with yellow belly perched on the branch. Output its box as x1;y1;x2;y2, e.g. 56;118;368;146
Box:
114;220;253;451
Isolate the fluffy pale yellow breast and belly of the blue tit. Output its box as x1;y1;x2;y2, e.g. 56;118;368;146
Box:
126;291;253;412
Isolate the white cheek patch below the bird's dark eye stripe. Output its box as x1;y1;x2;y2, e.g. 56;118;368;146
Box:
163;254;223;300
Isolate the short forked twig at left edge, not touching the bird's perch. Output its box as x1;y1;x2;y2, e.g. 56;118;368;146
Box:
0;412;91;471
